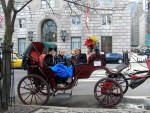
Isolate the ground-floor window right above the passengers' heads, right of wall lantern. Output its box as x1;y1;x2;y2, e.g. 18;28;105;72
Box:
71;37;81;50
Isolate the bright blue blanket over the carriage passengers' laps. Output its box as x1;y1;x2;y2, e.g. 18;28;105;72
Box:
50;64;73;78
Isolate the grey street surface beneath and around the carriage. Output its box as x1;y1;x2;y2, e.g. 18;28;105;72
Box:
15;63;150;108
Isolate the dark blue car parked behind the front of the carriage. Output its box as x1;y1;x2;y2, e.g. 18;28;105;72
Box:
106;53;123;64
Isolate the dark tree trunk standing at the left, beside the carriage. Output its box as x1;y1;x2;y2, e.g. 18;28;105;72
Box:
1;19;13;110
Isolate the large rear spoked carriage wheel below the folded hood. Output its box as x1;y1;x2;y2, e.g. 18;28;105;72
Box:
17;75;50;105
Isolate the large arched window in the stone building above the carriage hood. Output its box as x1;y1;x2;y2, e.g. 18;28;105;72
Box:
41;20;57;42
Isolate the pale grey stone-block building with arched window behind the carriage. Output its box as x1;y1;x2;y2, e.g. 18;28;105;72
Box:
0;0;131;53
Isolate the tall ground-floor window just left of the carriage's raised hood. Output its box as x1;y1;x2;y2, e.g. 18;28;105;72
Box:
18;38;26;54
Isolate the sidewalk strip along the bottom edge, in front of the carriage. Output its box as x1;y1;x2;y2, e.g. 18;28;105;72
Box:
2;105;150;113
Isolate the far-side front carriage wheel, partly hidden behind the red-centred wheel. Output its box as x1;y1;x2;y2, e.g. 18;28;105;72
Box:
115;78;129;94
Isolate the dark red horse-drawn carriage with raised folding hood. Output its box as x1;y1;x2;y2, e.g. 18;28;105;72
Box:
17;42;127;106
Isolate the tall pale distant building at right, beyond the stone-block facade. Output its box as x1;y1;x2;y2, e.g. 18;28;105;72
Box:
131;0;148;47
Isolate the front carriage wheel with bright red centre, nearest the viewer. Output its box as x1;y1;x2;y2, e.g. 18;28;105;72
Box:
94;78;123;107
